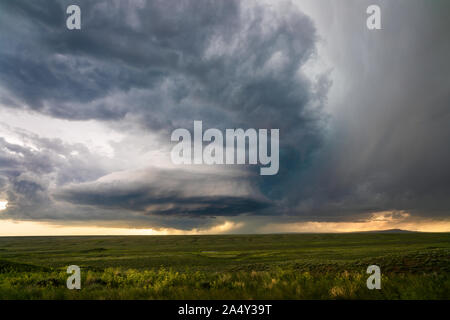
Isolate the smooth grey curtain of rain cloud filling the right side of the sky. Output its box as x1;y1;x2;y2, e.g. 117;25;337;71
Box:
278;1;450;221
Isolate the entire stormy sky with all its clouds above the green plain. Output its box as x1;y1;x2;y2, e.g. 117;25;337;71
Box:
0;0;450;236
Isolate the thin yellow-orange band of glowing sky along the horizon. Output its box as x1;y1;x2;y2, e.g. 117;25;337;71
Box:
0;212;450;236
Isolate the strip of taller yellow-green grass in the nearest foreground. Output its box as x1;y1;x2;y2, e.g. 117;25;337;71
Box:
0;268;450;299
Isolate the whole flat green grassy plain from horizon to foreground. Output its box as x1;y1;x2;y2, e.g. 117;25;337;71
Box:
0;233;450;299
